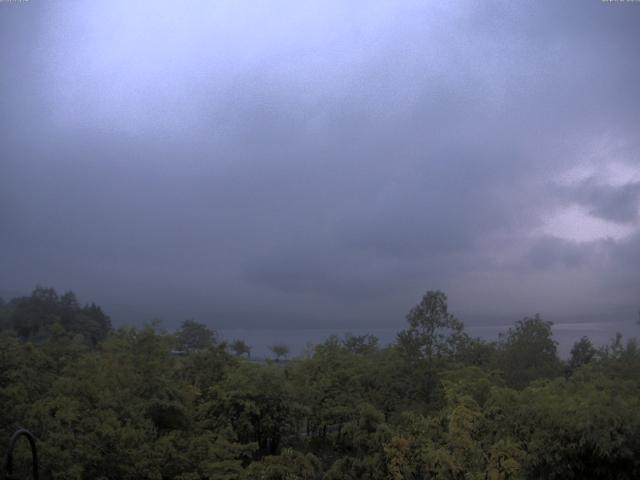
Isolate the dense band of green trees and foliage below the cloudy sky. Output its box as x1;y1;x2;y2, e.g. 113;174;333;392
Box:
0;288;640;480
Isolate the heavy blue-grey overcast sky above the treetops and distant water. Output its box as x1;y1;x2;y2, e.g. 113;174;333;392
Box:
0;0;640;328
